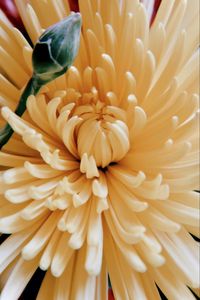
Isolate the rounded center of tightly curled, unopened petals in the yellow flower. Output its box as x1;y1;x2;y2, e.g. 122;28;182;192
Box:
65;100;130;168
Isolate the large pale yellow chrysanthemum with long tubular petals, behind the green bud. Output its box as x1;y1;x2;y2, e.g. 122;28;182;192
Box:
0;0;199;300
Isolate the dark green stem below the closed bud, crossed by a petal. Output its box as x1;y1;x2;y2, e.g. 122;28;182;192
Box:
0;76;42;149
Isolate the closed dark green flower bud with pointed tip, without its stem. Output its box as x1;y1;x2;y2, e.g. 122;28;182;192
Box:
32;13;81;84
